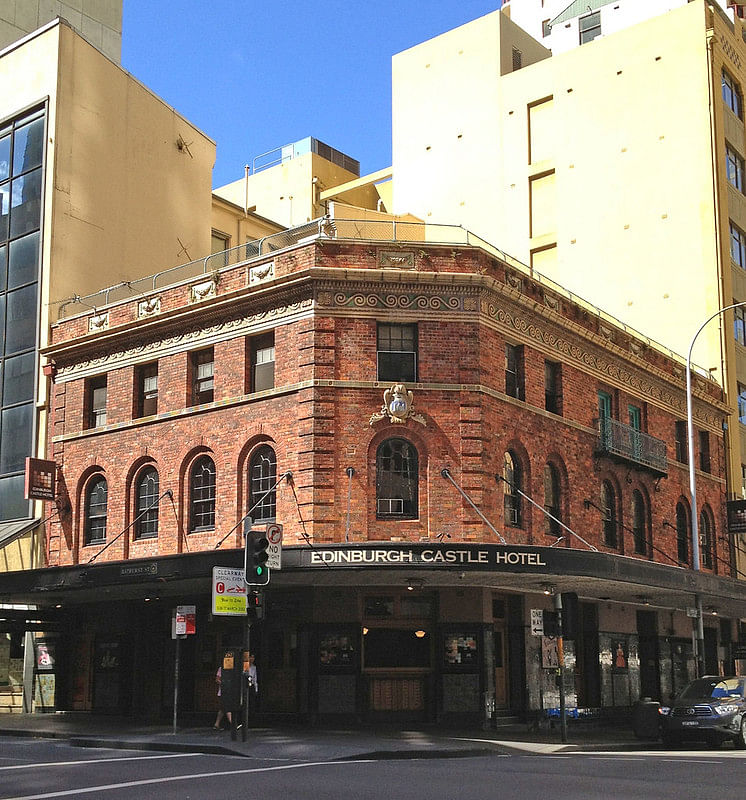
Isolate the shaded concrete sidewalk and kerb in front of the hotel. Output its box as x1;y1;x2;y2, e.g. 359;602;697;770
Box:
0;713;648;761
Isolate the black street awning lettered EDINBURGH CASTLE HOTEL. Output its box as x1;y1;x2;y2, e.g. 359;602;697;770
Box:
0;542;746;619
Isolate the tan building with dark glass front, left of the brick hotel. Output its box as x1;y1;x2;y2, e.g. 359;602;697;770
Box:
0;15;281;707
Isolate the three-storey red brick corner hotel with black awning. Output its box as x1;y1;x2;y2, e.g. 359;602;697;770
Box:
7;220;746;721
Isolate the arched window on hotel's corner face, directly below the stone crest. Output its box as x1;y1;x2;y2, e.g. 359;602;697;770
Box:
376;439;418;519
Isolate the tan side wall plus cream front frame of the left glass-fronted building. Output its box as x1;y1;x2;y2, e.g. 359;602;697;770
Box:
0;22;215;570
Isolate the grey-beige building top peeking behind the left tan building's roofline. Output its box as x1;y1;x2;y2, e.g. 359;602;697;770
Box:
0;0;122;63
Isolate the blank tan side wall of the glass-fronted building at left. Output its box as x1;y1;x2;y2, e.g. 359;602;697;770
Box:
45;26;215;316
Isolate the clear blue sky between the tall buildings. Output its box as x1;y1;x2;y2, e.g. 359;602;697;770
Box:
122;0;500;186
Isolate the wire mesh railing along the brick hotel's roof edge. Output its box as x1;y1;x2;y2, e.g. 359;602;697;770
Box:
53;212;711;379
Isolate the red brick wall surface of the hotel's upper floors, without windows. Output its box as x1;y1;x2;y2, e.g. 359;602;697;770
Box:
50;238;727;573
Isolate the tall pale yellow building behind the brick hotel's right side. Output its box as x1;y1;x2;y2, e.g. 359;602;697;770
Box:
391;0;746;580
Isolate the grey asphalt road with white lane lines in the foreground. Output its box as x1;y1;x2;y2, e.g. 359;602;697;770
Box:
0;738;746;800
